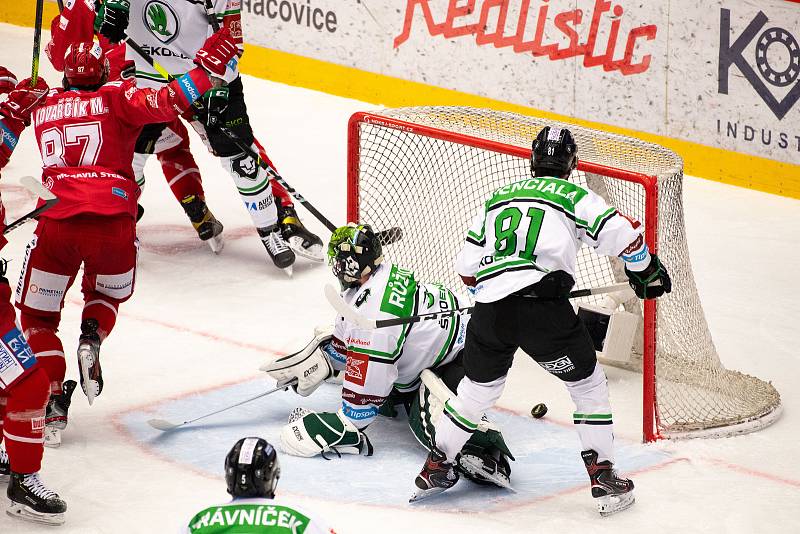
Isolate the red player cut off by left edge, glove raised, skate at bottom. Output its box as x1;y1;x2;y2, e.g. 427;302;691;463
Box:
0;72;67;524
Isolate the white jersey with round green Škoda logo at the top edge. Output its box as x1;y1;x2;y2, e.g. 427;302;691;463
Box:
125;0;243;89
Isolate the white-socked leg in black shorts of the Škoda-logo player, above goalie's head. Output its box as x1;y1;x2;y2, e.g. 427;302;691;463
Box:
192;78;295;269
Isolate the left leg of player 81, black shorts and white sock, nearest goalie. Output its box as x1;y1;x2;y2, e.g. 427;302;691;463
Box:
412;299;518;500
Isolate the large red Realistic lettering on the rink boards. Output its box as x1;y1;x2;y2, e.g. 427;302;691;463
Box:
394;0;658;76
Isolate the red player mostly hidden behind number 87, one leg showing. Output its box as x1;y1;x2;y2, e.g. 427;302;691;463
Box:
45;0;223;252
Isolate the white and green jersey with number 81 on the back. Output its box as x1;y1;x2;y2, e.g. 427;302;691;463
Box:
456;177;650;302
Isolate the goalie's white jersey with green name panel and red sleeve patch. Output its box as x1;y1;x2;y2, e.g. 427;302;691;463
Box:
325;264;469;429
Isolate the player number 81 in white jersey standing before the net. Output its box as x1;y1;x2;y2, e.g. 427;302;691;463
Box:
415;127;672;515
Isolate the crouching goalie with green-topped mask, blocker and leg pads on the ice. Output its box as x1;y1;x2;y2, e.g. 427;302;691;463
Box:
262;224;513;486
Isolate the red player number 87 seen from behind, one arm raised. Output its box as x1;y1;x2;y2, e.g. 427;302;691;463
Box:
16;30;236;452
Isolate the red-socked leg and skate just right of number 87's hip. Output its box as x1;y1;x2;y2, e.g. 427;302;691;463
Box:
155;119;223;253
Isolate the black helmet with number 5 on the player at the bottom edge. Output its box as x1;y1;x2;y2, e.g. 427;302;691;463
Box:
225;438;281;499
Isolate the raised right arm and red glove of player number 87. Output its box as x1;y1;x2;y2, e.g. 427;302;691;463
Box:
120;29;236;125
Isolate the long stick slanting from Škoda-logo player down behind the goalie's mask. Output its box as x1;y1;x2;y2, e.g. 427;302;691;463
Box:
125;35;403;245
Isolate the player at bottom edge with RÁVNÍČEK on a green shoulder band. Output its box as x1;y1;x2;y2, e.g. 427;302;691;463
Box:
181;438;336;534
